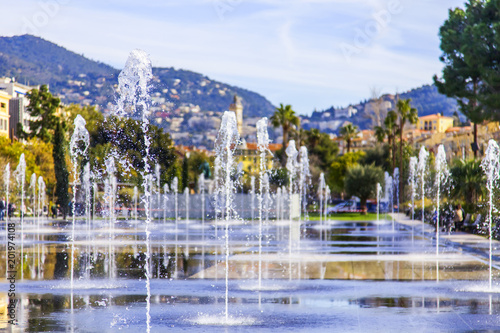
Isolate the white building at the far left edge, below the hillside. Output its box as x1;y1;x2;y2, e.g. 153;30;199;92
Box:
0;77;38;139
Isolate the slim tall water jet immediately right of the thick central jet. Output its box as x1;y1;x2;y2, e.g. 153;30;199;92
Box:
257;117;269;290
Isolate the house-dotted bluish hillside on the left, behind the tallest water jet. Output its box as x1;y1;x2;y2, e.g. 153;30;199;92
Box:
0;35;274;117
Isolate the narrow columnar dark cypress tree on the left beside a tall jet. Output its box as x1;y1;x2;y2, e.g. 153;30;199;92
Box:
52;121;69;219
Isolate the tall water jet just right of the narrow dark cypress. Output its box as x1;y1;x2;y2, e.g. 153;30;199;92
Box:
69;115;90;294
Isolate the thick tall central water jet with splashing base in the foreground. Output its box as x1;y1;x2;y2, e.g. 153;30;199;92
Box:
215;111;240;323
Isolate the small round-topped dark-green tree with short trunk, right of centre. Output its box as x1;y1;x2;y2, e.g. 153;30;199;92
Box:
344;164;384;214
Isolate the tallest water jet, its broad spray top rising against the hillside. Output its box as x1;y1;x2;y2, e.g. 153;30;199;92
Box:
116;49;153;332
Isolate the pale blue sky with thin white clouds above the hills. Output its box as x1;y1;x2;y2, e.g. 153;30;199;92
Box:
0;0;464;114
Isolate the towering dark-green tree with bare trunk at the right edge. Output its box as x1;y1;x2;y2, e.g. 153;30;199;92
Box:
434;0;491;158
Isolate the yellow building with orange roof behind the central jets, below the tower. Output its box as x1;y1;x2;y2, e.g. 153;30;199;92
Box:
234;143;283;175
